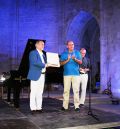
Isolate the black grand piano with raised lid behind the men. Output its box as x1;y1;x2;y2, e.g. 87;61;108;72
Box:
4;39;63;108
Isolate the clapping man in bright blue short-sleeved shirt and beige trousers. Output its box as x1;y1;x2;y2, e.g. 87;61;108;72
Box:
60;41;82;111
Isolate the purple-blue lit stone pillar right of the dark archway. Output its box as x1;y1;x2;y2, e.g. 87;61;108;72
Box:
100;0;120;97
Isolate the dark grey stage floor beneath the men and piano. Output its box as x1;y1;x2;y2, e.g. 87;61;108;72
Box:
0;94;120;129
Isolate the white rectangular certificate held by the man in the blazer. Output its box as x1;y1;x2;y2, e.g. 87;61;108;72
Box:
46;52;60;67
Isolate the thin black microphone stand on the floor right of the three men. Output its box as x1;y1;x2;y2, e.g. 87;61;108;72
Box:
88;71;100;121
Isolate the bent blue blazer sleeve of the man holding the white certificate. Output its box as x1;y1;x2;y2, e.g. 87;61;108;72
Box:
29;52;45;68
